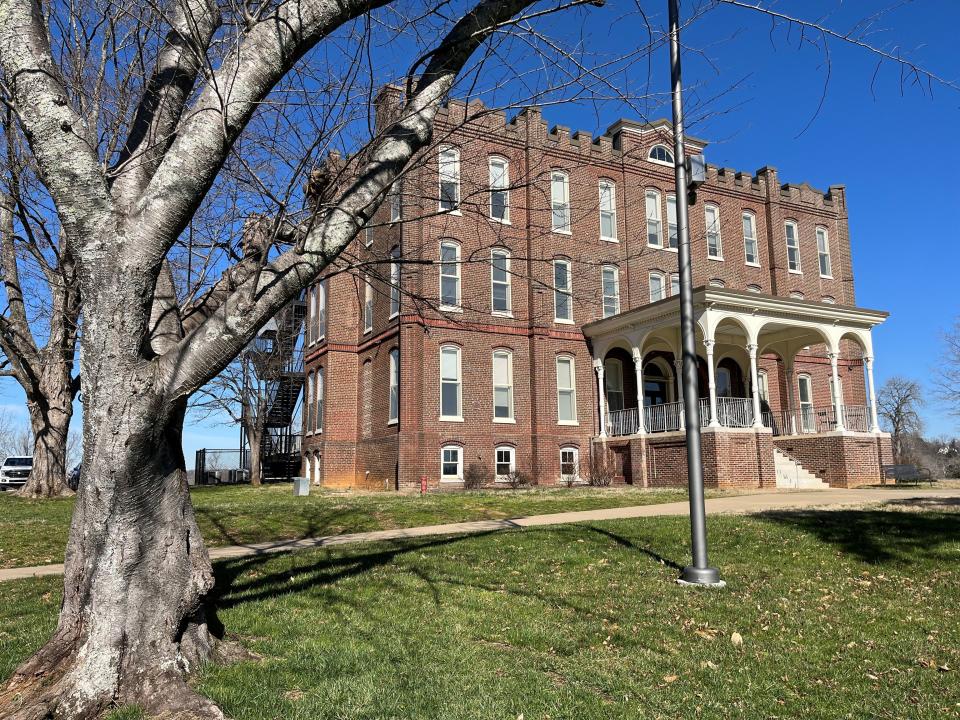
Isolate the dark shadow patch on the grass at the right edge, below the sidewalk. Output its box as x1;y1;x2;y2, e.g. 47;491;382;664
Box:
759;510;960;565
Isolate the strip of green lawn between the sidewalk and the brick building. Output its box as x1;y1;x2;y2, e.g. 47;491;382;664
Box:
0;483;723;568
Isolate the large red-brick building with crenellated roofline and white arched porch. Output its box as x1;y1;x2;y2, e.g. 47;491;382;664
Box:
303;88;890;489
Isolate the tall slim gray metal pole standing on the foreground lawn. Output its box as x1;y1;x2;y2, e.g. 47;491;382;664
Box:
668;0;720;585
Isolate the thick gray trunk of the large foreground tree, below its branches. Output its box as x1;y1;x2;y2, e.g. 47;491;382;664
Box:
0;315;233;720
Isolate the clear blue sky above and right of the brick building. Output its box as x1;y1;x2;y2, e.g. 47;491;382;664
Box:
0;0;960;467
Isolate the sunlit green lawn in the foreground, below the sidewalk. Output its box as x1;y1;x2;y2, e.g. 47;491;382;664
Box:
0;510;960;720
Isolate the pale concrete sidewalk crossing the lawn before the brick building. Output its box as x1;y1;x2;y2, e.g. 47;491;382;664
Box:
0;488;960;582
